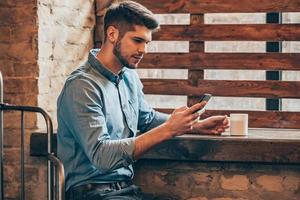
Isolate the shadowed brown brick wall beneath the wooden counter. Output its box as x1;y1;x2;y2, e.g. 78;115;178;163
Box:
135;160;300;200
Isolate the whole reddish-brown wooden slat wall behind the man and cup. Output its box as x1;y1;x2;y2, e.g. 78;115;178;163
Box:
95;0;300;128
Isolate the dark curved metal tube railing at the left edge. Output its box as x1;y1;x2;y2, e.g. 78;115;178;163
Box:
0;72;65;200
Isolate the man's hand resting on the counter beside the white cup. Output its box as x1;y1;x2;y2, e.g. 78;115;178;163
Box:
189;115;229;135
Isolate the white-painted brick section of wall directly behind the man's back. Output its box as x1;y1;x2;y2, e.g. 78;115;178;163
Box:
38;0;95;127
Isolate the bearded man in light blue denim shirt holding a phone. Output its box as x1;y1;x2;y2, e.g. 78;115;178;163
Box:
57;1;228;200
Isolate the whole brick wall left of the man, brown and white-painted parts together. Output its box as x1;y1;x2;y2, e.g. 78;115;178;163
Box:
0;0;95;199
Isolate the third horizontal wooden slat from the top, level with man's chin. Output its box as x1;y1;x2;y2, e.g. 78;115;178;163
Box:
139;52;300;70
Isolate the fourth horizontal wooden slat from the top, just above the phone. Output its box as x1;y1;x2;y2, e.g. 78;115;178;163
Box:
142;79;300;98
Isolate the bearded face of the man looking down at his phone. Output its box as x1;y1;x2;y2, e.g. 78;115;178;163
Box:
113;25;152;69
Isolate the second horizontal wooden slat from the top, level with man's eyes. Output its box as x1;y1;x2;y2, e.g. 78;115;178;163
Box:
153;24;300;41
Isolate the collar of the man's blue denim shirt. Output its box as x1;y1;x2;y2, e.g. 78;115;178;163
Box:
88;49;126;84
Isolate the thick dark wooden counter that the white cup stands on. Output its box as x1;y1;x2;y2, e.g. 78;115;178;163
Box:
30;129;300;164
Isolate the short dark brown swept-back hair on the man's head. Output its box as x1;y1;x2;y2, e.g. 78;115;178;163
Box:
104;1;159;41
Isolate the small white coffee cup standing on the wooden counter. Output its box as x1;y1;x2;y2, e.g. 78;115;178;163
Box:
230;113;248;136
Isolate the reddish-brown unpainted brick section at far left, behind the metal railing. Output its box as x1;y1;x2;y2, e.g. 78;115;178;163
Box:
0;0;39;199
